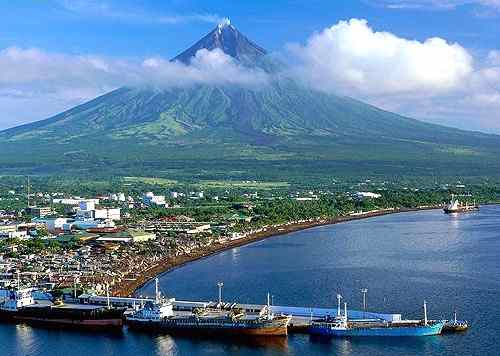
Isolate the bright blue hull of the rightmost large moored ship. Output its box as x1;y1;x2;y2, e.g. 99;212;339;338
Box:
309;323;444;337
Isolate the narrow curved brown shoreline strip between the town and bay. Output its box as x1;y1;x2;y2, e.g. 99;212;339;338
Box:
113;205;442;297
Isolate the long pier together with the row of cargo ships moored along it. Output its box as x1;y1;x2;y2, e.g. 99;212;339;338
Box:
0;278;468;337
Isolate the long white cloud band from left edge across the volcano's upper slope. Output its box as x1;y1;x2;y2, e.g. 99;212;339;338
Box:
0;47;269;129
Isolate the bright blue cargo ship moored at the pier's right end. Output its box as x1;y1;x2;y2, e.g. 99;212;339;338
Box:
309;302;445;337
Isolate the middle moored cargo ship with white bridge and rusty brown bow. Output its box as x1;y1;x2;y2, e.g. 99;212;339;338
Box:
126;279;291;336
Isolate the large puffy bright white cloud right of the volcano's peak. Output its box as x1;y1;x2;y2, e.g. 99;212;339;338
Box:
291;19;472;95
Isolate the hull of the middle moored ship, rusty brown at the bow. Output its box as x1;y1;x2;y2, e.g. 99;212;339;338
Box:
127;319;289;336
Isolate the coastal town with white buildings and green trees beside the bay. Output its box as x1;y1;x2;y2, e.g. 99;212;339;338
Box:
0;180;494;296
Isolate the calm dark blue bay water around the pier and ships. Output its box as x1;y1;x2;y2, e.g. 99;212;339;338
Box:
0;206;500;356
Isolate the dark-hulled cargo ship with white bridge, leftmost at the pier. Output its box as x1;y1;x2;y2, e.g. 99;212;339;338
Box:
0;288;125;329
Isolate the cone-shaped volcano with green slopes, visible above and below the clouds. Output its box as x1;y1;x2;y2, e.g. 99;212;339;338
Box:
0;22;500;177
